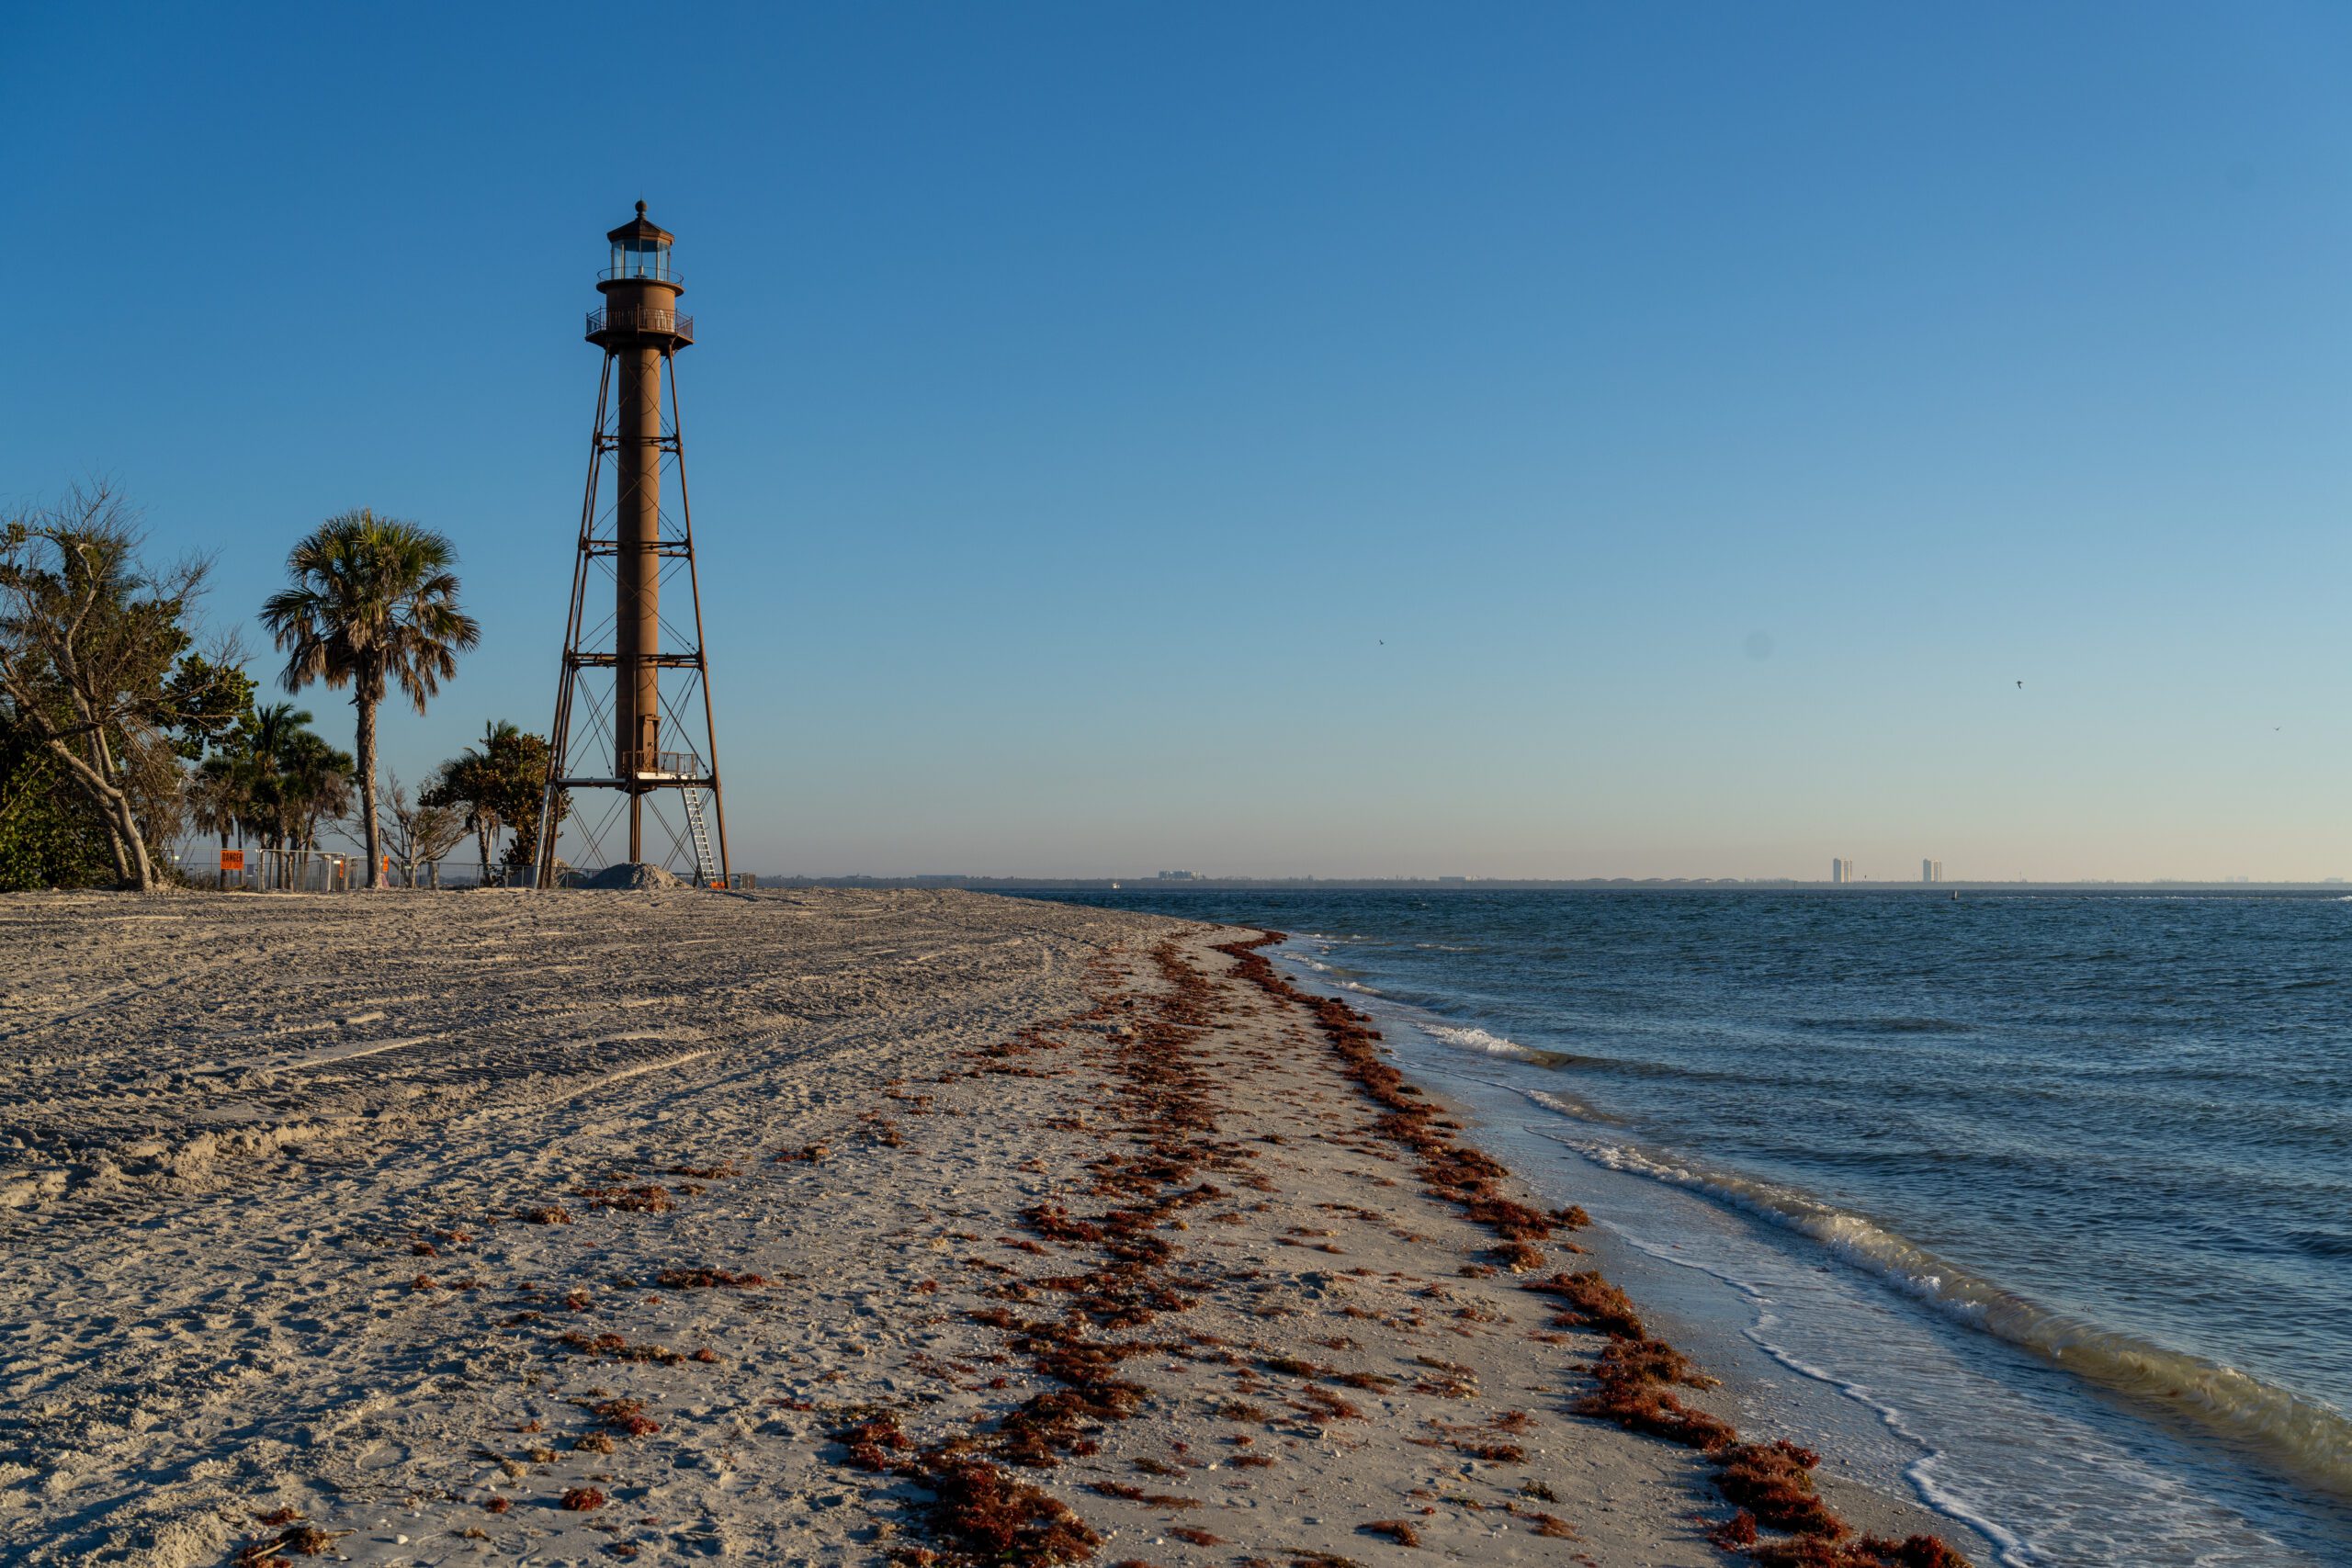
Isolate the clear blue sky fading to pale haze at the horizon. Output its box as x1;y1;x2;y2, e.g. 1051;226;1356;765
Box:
0;3;2352;877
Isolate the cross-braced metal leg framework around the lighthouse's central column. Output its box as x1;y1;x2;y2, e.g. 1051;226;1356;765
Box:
538;348;729;888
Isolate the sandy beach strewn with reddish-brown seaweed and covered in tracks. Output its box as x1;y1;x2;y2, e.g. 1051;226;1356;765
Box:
0;891;1933;1568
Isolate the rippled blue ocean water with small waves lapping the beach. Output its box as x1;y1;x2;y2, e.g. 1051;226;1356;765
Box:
1025;888;2352;1568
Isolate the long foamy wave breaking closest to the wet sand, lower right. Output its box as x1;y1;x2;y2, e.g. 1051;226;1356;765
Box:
1562;1128;2352;1497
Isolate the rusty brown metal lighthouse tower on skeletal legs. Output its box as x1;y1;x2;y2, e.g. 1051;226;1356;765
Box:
538;202;727;886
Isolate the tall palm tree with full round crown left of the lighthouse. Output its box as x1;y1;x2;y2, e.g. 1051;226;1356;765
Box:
261;508;482;888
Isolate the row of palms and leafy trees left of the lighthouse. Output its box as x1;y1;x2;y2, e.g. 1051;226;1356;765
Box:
0;484;570;891
